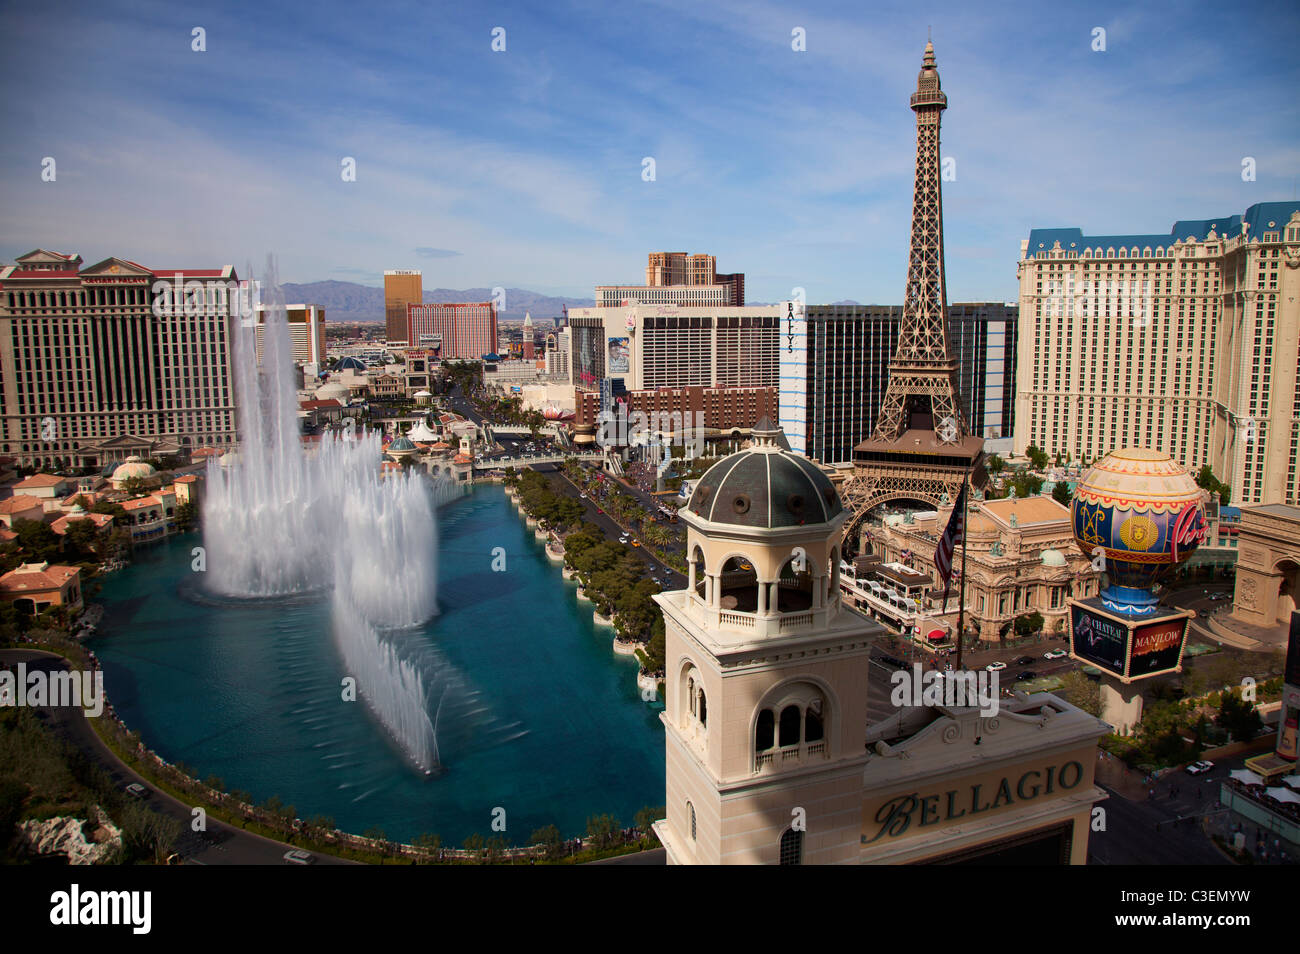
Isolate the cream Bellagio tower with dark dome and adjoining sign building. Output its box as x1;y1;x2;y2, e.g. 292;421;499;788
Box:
655;419;1109;864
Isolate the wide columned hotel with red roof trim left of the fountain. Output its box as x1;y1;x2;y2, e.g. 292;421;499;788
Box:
0;248;241;467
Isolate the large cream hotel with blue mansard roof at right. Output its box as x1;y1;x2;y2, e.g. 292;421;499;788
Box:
1015;201;1300;504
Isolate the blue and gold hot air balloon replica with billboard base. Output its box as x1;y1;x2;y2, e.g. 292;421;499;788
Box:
1070;447;1208;734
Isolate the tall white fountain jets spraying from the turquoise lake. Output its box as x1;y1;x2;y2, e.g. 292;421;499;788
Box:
203;266;439;772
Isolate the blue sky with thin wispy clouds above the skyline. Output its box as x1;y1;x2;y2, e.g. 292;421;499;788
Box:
0;0;1300;303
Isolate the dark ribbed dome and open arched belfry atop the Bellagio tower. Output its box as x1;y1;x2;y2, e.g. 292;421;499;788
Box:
679;417;849;643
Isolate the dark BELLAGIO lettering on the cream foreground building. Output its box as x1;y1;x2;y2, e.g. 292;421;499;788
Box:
862;762;1083;845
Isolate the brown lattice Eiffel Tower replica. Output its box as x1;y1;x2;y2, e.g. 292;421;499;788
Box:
840;42;985;538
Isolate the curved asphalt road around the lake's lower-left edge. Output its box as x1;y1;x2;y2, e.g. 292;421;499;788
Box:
0;650;355;864
